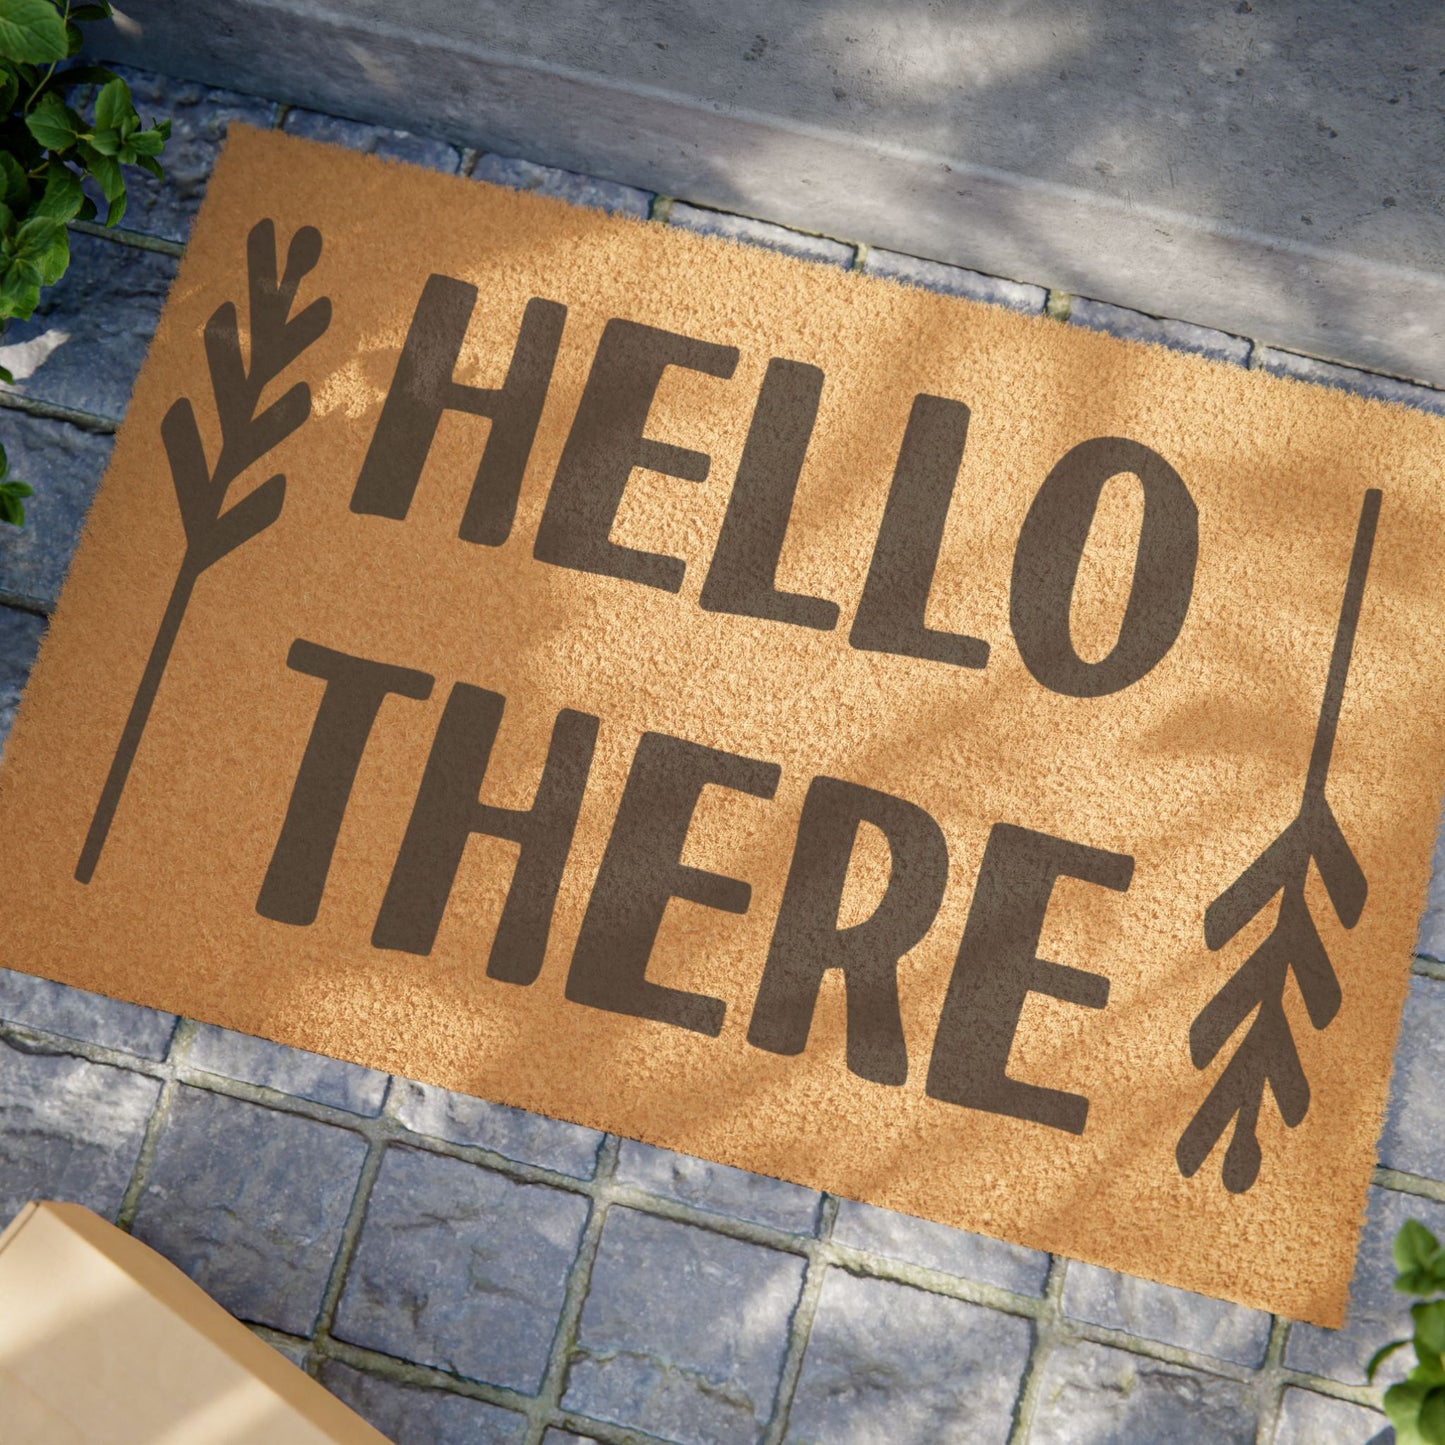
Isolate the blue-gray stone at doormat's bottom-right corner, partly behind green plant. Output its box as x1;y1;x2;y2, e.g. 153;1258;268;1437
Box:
1285;1189;1445;1384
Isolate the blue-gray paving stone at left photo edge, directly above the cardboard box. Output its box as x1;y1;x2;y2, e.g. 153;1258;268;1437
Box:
0;1039;160;1228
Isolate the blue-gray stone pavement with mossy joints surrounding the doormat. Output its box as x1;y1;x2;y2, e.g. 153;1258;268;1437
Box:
0;65;1445;1445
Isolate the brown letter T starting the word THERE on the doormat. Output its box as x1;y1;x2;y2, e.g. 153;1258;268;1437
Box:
256;637;432;923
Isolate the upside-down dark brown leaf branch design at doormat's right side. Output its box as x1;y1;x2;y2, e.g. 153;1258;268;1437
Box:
1175;487;1381;1194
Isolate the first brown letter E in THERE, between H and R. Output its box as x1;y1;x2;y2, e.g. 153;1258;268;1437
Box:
566;733;782;1038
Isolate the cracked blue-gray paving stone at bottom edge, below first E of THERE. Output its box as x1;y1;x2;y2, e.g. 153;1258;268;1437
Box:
562;1208;803;1445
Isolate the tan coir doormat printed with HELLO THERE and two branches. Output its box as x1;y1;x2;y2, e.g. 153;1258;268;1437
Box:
0;130;1445;1324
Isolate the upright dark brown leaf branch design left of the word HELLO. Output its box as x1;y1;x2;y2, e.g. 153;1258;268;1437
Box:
75;220;331;883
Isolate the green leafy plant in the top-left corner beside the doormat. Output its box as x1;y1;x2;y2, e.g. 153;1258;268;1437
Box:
0;0;171;526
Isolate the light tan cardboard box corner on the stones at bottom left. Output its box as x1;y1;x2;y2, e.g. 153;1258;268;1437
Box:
0;1202;386;1445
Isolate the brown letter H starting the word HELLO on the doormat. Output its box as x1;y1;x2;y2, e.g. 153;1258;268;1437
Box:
351;276;566;546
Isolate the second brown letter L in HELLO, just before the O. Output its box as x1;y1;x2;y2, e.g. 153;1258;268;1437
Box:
848;394;988;668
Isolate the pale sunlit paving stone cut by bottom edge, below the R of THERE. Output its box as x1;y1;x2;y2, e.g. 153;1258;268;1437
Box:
786;1269;1033;1445
